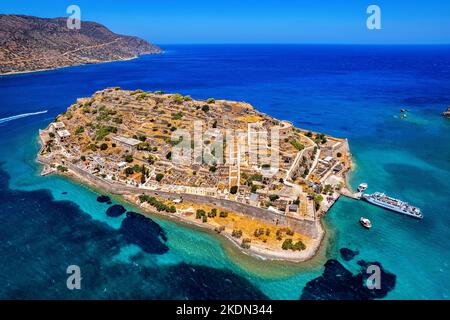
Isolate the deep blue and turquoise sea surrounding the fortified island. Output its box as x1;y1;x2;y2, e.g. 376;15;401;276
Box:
0;45;450;299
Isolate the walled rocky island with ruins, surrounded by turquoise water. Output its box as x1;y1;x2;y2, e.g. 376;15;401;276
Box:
37;87;352;261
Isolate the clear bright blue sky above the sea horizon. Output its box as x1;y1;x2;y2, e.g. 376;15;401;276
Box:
0;0;450;44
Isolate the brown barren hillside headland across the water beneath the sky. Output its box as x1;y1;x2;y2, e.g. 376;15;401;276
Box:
0;14;161;75
